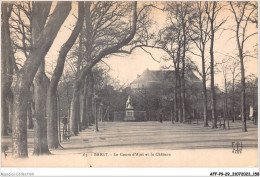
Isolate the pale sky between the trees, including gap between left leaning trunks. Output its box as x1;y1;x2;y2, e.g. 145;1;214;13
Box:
43;1;258;88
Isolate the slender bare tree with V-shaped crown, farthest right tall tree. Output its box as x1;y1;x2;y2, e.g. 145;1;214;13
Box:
229;1;258;132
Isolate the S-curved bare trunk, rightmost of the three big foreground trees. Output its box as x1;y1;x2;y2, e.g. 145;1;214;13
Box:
47;2;84;149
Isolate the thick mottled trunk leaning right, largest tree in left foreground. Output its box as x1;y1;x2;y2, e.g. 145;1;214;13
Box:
12;2;71;158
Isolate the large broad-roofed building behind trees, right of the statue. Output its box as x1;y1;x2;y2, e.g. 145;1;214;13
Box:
130;69;202;120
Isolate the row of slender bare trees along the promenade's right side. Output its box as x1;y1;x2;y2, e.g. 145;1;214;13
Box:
145;1;257;131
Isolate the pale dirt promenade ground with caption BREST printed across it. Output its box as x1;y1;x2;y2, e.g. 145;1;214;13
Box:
2;121;258;167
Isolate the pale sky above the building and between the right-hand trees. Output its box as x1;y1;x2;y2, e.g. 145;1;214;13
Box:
104;1;258;88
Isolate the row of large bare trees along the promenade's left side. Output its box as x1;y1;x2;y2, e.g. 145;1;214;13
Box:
2;2;152;158
